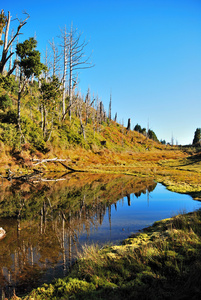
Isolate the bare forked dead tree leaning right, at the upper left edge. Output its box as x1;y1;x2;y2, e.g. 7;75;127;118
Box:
0;10;30;75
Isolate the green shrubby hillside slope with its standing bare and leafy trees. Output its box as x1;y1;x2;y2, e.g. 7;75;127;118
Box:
0;10;200;154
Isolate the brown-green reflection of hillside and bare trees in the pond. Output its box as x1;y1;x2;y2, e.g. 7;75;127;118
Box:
0;174;156;298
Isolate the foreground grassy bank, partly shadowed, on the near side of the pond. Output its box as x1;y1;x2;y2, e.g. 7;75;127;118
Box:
17;211;201;300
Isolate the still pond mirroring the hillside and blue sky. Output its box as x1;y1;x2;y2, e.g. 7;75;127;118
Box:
0;174;201;297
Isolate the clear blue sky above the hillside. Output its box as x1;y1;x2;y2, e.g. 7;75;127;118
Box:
2;0;201;144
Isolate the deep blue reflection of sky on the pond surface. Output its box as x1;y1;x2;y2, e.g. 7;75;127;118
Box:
81;184;201;242
